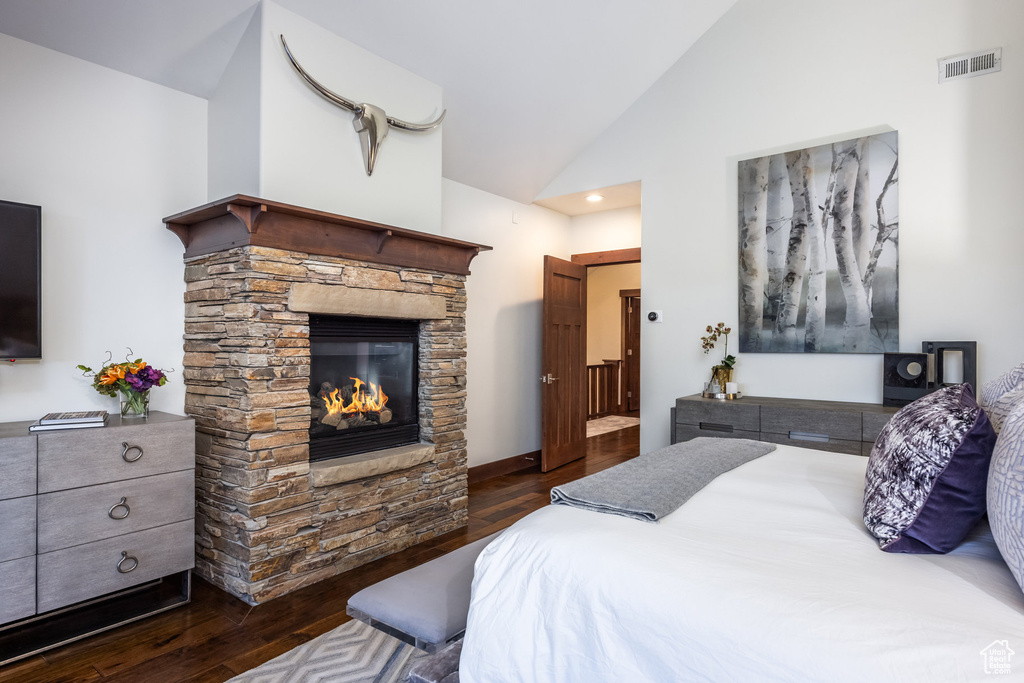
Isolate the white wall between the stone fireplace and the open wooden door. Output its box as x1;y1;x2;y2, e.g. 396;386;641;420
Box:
443;180;569;467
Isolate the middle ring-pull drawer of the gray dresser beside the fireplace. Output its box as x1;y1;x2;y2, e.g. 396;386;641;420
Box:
38;470;196;553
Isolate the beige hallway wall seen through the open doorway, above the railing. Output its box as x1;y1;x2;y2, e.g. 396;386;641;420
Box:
587;263;640;366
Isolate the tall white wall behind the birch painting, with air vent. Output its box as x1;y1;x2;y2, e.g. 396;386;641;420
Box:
543;0;1024;452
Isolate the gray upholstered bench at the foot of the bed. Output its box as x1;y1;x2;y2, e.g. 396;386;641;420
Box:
346;533;498;652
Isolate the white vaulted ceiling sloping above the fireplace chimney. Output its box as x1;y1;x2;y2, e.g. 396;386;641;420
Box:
0;0;736;203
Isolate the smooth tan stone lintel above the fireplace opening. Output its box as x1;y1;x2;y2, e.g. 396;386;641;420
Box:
288;283;447;321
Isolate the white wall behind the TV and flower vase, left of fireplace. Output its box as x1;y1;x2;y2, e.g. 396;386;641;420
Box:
0;35;207;421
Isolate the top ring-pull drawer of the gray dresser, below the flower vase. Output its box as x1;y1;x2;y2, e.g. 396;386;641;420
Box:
39;420;196;494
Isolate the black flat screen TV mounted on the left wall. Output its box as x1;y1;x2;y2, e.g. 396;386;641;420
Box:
0;201;43;360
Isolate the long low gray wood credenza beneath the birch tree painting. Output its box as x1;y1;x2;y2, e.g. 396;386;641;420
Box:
672;394;899;456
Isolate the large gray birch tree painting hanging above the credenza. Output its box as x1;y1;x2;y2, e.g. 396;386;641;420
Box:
738;131;899;353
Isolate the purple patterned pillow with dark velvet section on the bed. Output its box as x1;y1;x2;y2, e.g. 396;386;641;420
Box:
864;384;995;553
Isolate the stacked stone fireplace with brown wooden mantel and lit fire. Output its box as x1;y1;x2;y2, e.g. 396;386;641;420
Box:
165;196;489;604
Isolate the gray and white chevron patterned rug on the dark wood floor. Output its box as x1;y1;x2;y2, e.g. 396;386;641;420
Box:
228;620;427;683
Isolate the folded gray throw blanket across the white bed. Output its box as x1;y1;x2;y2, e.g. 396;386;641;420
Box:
551;436;775;522
